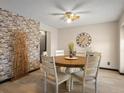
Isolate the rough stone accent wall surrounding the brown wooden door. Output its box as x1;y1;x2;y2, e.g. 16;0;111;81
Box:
0;8;40;81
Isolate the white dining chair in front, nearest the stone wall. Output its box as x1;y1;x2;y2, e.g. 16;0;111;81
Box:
42;56;70;93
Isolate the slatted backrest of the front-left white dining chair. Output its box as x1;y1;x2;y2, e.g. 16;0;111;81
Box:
42;56;57;79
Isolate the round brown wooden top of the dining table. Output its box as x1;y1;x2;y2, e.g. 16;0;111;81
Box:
55;56;86;68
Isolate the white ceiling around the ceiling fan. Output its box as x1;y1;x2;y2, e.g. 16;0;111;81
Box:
0;0;124;28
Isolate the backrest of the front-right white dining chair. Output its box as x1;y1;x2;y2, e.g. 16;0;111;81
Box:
85;52;101;77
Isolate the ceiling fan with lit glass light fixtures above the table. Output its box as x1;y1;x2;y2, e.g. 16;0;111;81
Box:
51;2;90;23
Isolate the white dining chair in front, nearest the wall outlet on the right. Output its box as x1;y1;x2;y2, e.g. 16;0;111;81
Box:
72;52;101;93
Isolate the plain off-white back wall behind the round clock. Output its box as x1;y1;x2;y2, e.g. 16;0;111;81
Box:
58;22;119;69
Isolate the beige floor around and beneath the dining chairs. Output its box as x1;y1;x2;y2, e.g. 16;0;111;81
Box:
0;70;124;93
